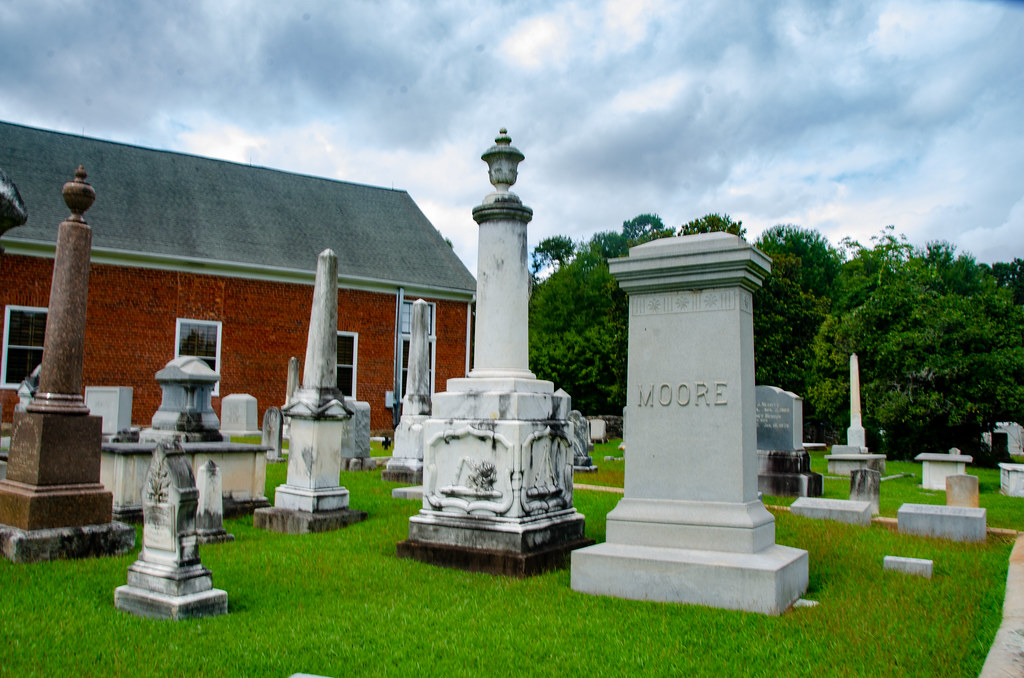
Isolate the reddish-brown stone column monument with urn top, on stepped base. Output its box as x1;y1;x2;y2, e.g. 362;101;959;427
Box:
0;166;134;561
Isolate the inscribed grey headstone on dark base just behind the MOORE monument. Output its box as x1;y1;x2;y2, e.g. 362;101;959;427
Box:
754;386;822;497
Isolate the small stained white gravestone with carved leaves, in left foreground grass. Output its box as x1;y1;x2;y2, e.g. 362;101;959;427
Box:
114;441;227;620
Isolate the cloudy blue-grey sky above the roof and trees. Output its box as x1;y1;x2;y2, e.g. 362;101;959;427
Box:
0;0;1024;270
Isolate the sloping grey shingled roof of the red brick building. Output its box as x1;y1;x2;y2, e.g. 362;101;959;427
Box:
0;122;476;292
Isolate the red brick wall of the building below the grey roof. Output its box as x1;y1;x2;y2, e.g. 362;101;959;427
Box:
0;253;466;430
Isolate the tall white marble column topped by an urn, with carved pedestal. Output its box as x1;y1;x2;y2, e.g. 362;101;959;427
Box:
397;129;590;576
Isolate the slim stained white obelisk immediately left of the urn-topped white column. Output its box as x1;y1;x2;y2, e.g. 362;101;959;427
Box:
381;299;430;484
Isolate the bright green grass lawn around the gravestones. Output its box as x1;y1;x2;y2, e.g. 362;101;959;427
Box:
0;447;1024;678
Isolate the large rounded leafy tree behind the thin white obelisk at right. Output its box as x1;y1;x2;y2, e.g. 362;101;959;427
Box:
809;236;1024;463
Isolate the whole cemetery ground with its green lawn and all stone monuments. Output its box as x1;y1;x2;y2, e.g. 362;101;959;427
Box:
0;134;1024;676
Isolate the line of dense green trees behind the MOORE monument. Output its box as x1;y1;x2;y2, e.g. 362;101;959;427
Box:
529;214;1024;463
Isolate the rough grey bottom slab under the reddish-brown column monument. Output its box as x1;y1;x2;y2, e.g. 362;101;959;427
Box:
0;521;135;562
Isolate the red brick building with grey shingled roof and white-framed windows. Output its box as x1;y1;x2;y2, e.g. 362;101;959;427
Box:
0;122;476;431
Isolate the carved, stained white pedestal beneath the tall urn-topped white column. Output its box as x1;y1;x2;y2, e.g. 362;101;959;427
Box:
397;377;593;577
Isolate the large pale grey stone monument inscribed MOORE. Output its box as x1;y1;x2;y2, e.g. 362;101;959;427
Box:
571;232;808;615
